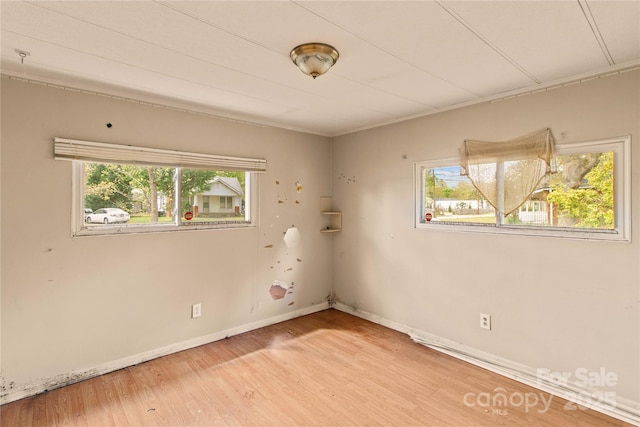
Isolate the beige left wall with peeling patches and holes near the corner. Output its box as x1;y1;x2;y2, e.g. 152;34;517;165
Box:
0;78;332;402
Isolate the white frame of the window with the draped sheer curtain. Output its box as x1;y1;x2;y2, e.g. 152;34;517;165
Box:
413;135;631;243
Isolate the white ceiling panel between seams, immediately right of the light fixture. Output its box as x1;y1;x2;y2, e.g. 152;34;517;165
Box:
298;2;533;96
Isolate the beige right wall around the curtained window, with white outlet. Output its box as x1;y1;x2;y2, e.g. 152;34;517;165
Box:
333;71;640;402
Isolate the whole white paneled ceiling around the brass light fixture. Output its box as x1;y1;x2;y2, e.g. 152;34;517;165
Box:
0;0;640;136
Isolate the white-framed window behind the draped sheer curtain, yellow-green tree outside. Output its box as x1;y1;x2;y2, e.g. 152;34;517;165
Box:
415;136;631;241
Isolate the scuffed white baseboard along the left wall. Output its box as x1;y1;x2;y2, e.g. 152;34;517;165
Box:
0;302;329;405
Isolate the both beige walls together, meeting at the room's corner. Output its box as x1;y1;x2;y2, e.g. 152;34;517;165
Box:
0;71;640;412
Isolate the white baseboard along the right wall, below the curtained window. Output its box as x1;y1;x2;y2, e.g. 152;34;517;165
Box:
333;302;640;426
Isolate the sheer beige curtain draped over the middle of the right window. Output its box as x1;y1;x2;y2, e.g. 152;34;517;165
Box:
460;129;554;215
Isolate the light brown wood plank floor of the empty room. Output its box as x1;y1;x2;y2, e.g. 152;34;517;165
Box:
0;310;630;427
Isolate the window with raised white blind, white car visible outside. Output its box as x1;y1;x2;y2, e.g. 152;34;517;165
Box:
55;138;266;235
